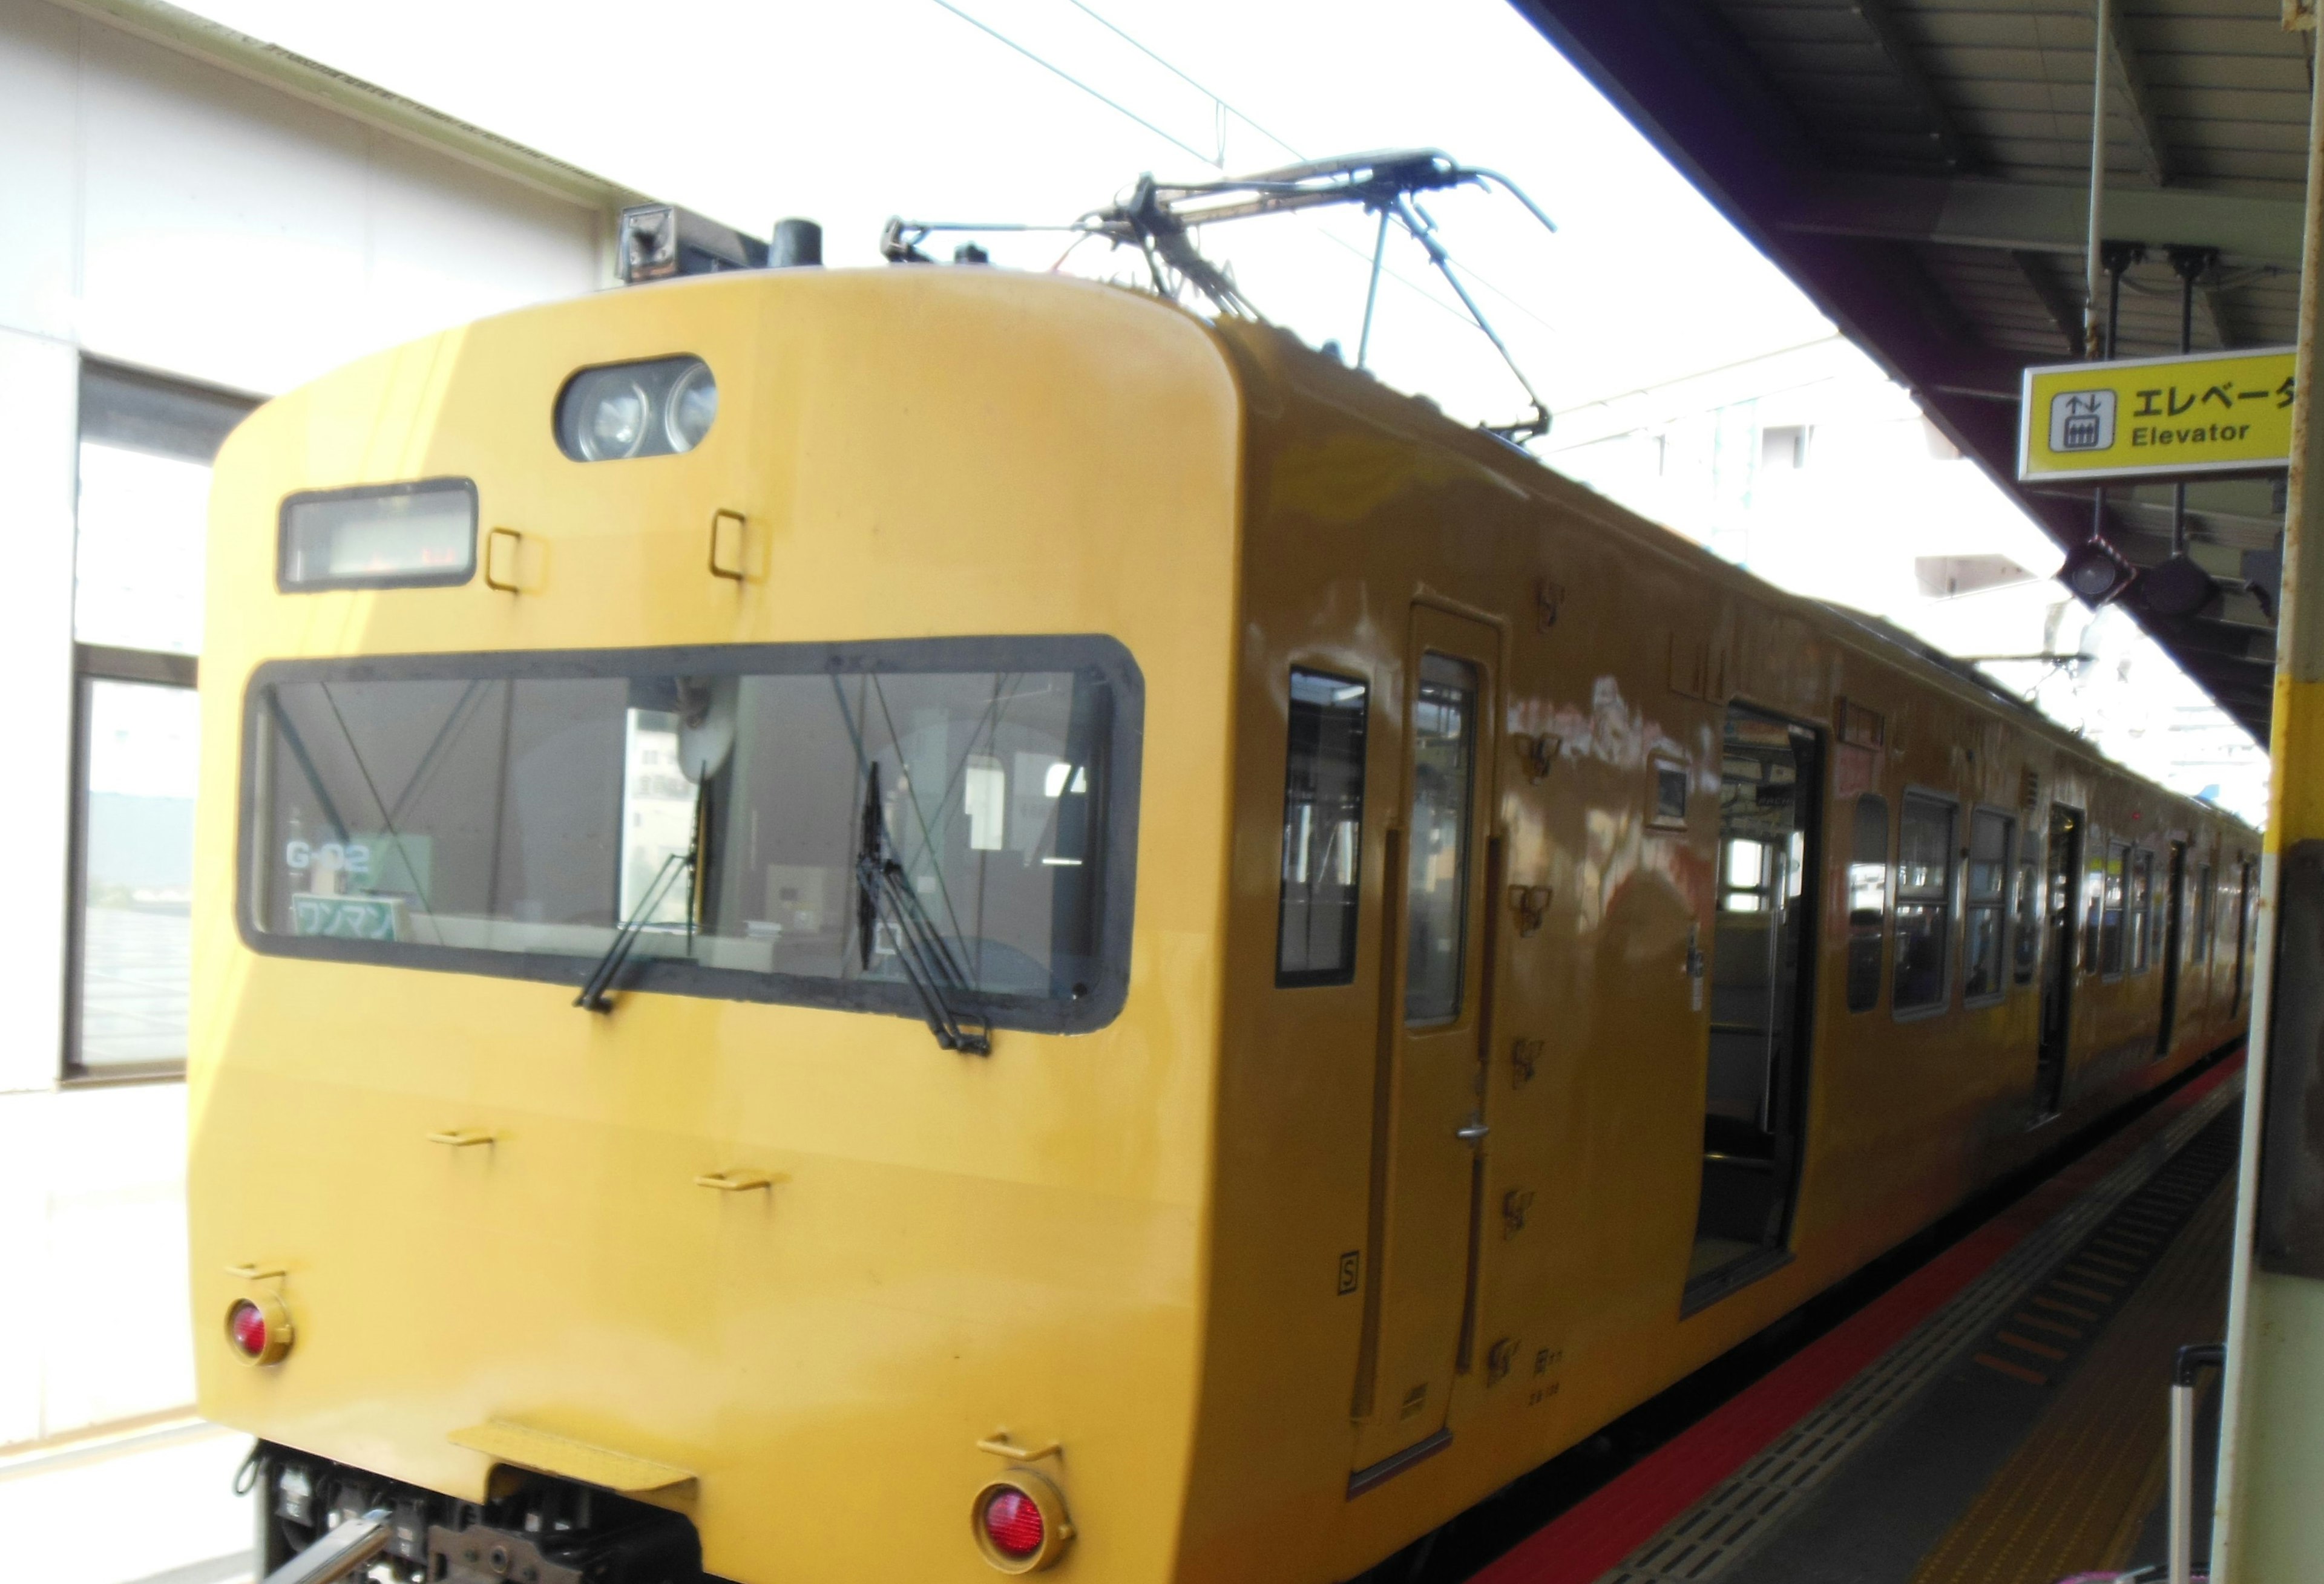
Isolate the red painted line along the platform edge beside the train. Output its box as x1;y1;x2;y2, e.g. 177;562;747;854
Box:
1474;1050;2243;1584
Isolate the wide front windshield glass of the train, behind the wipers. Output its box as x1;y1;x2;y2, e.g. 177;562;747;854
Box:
244;639;1139;1029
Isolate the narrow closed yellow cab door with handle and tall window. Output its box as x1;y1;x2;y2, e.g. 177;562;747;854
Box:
1348;606;1502;1496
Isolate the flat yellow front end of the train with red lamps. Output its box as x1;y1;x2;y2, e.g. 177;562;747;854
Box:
188;269;1239;1584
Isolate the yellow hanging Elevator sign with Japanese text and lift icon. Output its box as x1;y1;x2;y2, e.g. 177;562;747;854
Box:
2017;346;2291;483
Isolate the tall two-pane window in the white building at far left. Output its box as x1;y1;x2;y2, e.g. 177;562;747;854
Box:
63;362;254;1078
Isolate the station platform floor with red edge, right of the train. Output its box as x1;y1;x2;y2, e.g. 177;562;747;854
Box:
1469;1052;2243;1584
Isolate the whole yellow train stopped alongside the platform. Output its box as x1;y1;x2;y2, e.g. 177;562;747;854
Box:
191;253;2257;1584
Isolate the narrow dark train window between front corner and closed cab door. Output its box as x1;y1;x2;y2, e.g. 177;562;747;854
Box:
1276;667;1371;987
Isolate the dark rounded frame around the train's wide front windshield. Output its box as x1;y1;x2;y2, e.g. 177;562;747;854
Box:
235;634;1146;1033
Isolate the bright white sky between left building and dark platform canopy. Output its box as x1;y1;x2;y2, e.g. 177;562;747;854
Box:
172;0;1831;421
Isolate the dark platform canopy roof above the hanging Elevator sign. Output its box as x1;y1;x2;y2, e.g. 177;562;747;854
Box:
1513;0;2310;743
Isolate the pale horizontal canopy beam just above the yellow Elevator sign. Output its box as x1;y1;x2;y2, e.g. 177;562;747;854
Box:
1773;174;2301;265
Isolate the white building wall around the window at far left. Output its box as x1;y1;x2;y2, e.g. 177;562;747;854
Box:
0;0;614;1451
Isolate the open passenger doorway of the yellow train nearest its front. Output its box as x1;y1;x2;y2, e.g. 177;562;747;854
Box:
1685;704;1822;1310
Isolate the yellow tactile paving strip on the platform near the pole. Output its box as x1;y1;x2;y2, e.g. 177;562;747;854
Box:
1912;1177;2236;1584
